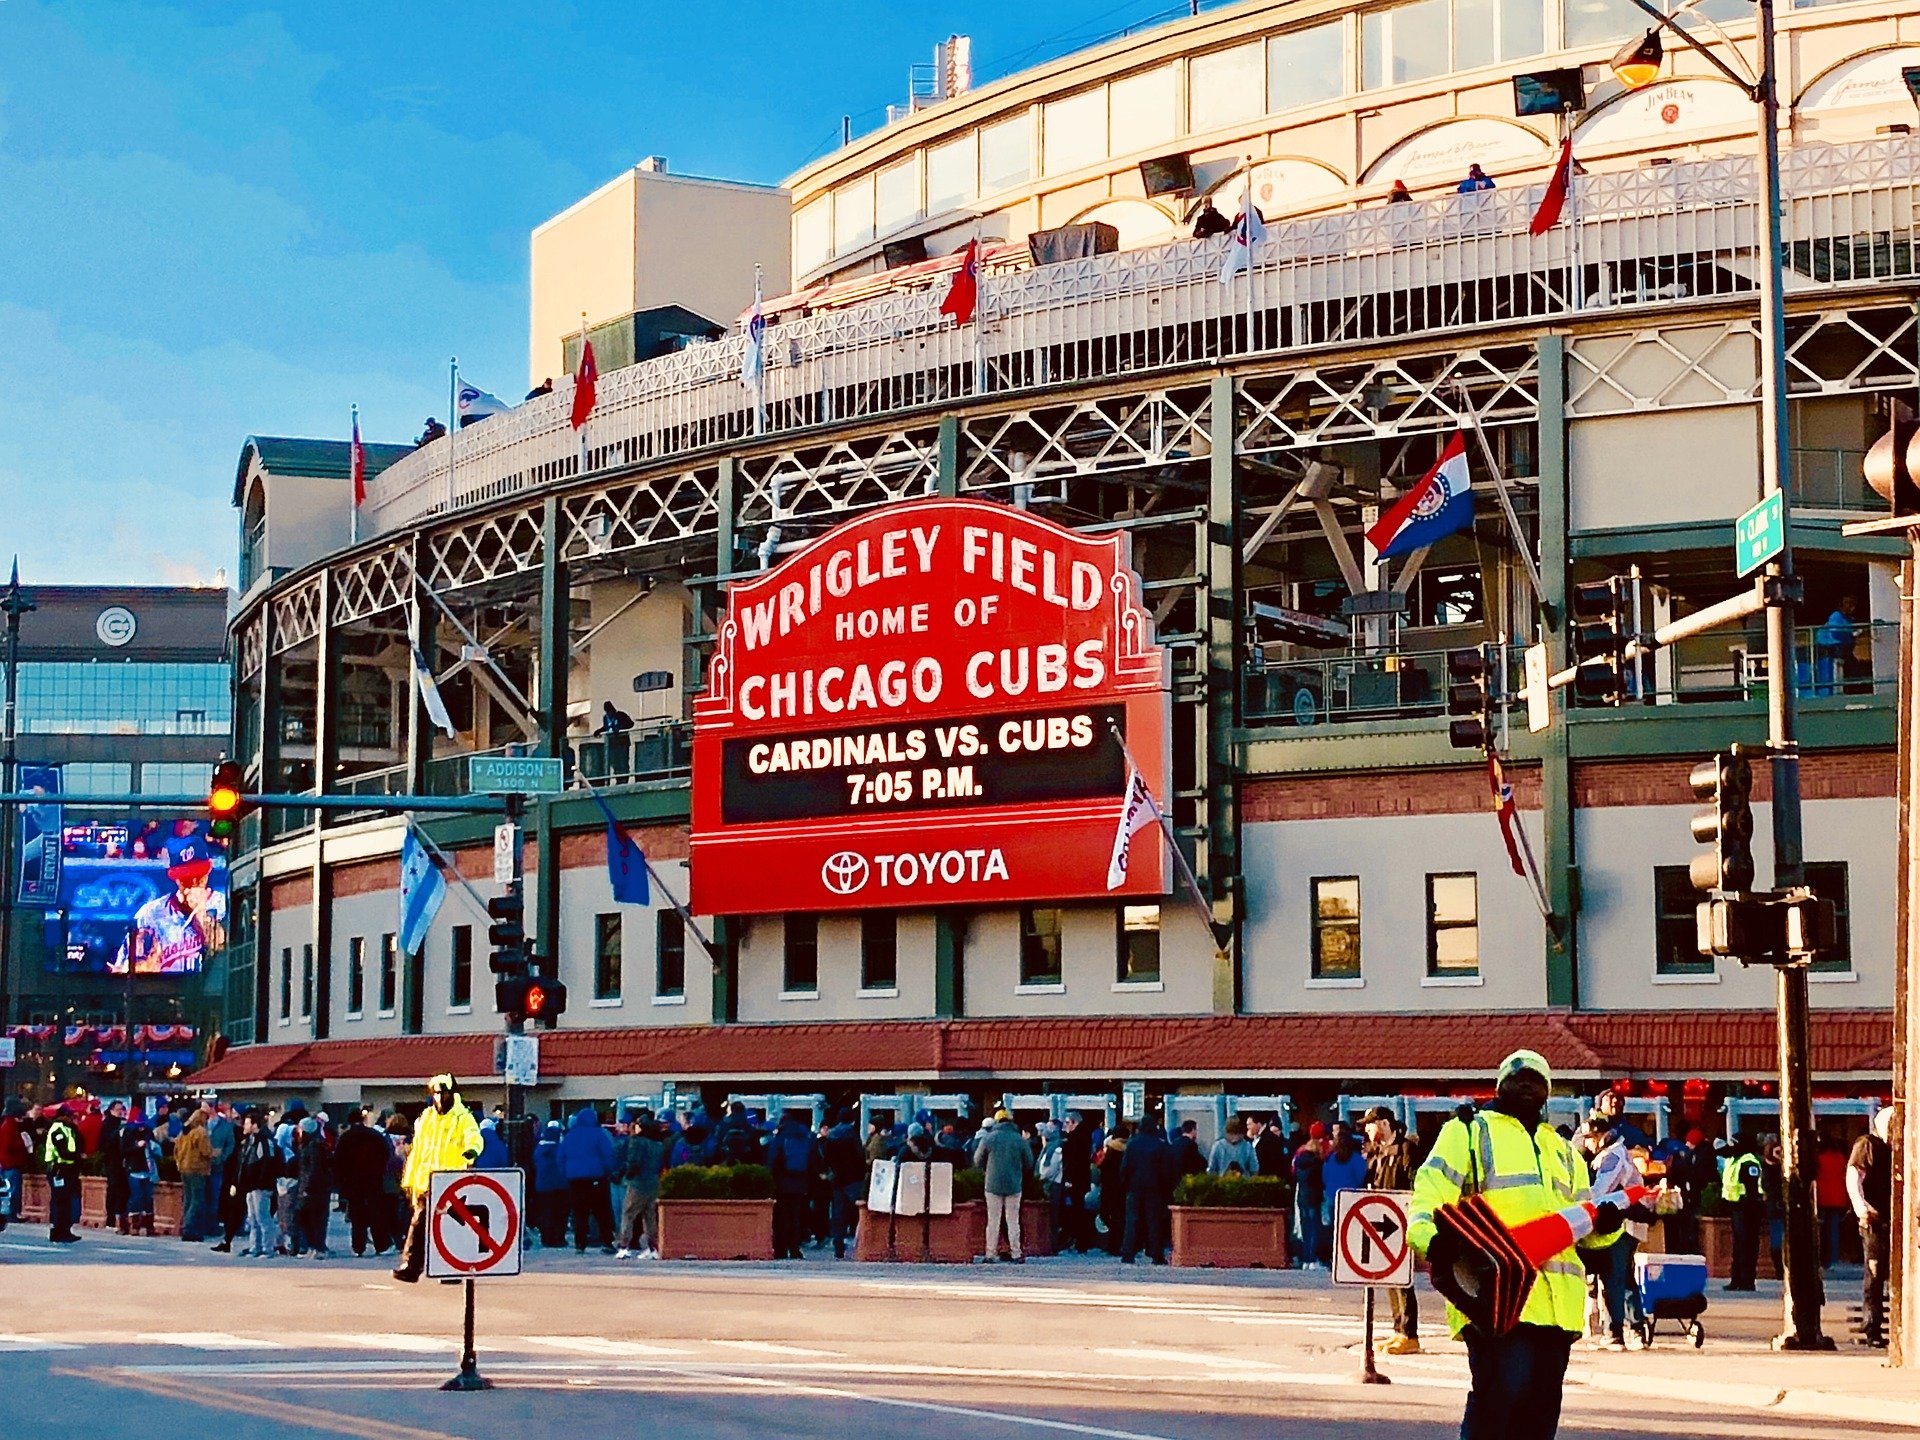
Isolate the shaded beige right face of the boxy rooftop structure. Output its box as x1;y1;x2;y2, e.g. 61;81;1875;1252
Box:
634;171;793;324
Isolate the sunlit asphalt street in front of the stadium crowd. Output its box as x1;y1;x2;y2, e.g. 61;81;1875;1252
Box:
0;1229;1907;1440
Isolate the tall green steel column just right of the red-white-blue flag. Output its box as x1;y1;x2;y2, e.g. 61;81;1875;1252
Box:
1538;334;1580;1010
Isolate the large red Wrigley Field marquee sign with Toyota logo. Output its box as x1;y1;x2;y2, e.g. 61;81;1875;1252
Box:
691;499;1169;914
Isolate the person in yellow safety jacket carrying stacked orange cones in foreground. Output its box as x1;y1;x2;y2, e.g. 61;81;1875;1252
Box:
1407;1050;1622;1440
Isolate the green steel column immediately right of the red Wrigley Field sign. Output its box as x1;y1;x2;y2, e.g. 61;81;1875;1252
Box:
1194;374;1244;1014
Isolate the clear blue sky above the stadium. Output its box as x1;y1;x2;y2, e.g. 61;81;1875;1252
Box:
0;0;1169;584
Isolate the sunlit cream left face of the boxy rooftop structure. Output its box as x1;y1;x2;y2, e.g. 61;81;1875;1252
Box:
526;171;639;388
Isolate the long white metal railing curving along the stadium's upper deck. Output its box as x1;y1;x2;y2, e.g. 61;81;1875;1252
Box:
367;136;1920;534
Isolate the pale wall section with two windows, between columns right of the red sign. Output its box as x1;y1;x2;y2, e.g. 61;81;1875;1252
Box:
1240;814;1548;1014
